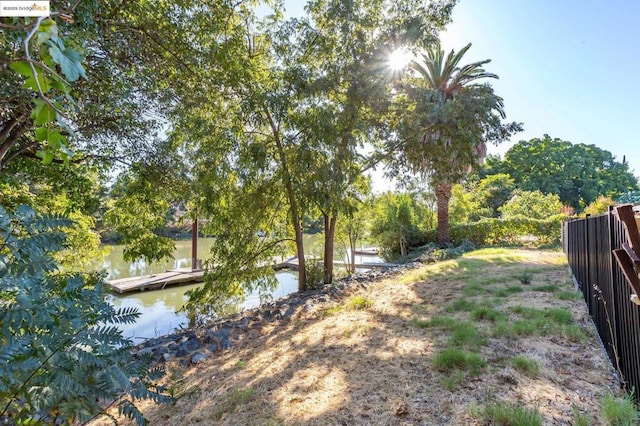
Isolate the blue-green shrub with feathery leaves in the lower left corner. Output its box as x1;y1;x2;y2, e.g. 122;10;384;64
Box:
0;206;171;424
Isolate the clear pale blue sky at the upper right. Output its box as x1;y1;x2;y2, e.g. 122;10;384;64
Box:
285;0;640;188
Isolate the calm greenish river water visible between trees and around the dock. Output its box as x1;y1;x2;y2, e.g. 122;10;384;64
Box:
102;235;382;342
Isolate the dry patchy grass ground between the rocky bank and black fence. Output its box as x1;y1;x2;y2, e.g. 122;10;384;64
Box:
90;249;616;425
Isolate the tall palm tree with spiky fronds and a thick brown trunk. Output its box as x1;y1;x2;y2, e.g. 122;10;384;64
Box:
408;43;505;244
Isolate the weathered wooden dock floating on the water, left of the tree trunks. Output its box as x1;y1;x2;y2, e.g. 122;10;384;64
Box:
106;268;204;294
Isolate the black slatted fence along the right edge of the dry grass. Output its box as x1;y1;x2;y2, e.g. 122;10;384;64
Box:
562;206;640;392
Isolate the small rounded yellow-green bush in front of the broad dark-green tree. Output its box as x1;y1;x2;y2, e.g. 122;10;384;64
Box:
499;190;562;219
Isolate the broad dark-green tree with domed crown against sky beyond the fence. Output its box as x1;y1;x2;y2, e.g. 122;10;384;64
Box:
500;135;638;211
